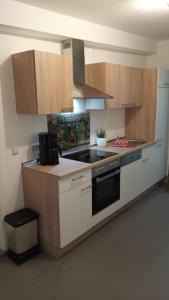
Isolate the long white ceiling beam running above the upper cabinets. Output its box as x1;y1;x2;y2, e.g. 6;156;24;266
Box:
0;0;157;54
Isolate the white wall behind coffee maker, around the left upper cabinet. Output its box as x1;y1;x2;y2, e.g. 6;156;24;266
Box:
0;35;60;248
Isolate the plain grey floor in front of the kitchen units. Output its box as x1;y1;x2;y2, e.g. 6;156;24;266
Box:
0;186;169;300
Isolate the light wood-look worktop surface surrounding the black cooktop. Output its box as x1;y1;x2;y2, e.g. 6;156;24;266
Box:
24;141;155;179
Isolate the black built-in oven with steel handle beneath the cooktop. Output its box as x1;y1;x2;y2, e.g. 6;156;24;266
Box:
92;160;120;215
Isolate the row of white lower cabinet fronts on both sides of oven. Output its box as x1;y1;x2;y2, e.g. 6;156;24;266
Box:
59;144;167;248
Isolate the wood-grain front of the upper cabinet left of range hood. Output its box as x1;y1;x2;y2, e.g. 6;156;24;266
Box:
35;51;73;114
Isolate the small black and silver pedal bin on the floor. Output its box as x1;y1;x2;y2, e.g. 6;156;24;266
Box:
5;208;41;265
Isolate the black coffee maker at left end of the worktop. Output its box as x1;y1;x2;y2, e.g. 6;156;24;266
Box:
39;132;62;165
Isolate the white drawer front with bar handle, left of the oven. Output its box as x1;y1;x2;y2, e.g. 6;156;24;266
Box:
59;170;91;194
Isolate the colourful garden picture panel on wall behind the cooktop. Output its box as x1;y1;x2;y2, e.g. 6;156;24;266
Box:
48;112;90;150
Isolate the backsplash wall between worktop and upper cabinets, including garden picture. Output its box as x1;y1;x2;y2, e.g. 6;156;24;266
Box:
48;109;125;151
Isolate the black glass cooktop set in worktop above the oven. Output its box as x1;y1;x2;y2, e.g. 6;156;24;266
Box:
62;149;117;164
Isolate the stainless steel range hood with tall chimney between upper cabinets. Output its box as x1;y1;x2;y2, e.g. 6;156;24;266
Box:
61;39;113;99
